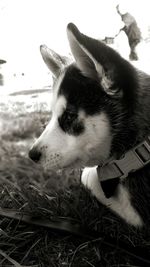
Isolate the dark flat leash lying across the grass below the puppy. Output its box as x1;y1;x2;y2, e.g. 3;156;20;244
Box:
0;208;150;267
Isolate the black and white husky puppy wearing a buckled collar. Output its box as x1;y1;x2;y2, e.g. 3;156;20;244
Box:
29;23;150;227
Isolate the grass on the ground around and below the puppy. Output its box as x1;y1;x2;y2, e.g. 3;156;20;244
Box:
0;91;150;267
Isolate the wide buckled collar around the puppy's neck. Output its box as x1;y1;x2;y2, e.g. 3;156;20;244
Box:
97;136;150;198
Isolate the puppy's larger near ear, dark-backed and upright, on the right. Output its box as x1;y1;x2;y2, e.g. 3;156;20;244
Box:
67;23;131;96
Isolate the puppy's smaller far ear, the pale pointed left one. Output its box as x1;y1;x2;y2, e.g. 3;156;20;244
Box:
40;45;68;77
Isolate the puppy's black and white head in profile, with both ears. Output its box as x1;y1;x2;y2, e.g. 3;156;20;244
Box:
29;24;139;169
